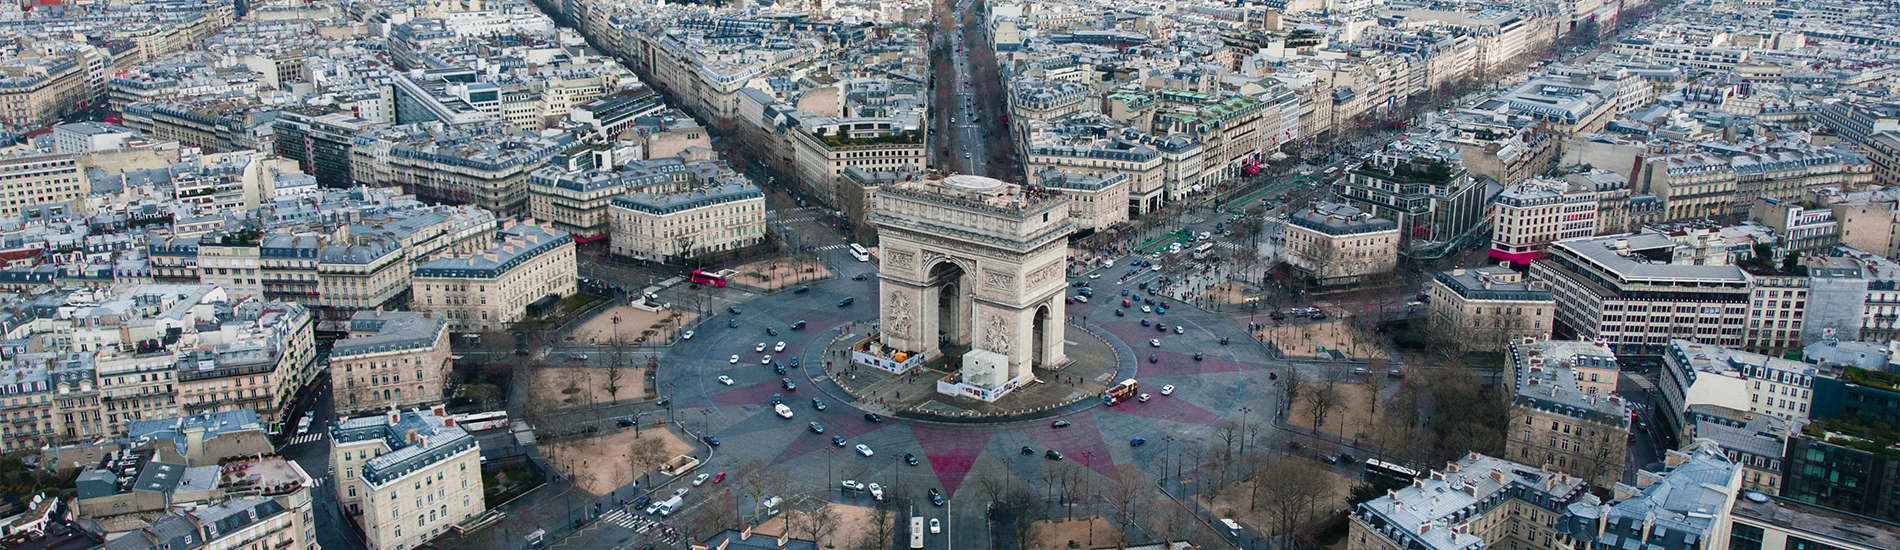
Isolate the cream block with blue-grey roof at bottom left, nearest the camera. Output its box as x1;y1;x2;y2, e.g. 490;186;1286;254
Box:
331;407;486;550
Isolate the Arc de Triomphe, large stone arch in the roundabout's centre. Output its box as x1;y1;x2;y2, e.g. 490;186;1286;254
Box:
870;175;1074;382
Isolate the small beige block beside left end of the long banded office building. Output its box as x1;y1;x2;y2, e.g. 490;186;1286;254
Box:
1425;266;1556;352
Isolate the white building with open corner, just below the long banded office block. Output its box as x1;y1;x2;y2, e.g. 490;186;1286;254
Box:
1657;341;1818;441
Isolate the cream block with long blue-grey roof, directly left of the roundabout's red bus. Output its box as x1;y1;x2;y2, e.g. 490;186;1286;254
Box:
410;223;576;333
